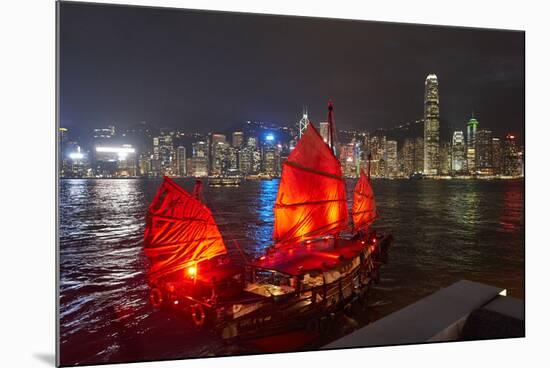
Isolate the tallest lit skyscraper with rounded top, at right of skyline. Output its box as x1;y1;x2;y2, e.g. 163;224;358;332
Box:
424;74;439;175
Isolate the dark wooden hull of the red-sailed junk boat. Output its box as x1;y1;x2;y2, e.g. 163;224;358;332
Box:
149;230;393;341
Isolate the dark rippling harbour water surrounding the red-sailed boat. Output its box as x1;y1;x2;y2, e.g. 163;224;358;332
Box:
59;179;524;364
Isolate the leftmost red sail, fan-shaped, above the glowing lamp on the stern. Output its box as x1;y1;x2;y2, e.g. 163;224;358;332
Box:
145;177;227;283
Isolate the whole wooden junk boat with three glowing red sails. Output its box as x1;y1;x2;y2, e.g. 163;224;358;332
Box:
144;103;392;339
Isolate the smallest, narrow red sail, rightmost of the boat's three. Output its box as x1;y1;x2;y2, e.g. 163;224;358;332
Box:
352;170;376;231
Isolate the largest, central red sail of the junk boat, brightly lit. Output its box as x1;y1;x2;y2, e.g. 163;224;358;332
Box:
273;123;348;243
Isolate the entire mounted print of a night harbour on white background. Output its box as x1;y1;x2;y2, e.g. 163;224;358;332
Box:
56;1;525;366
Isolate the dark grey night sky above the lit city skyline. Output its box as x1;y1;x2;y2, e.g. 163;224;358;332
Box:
59;3;525;141
